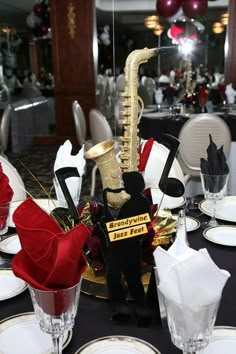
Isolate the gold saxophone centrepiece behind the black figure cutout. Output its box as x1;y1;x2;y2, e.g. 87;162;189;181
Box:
85;47;176;208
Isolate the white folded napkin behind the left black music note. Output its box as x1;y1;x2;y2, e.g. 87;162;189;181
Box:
53;140;86;207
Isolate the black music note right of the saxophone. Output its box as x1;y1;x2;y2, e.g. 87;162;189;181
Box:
159;134;184;198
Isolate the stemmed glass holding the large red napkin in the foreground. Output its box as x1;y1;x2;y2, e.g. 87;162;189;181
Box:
29;281;81;354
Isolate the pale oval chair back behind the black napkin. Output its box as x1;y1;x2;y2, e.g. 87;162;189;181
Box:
178;113;231;176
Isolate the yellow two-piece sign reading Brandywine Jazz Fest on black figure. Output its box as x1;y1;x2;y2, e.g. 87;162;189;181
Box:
106;213;151;242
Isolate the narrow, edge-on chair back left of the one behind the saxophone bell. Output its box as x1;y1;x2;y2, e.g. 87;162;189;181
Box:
72;100;86;146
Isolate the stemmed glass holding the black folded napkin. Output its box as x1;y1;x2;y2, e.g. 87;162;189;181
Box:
201;173;229;228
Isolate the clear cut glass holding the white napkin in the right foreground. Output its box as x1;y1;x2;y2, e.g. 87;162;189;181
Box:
164;296;220;354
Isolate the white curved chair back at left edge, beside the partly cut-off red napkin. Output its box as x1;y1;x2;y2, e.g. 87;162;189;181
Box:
0;156;27;202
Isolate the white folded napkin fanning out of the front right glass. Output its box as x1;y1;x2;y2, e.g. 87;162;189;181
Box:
154;238;230;308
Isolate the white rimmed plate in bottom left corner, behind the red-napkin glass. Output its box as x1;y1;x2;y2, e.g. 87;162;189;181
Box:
0;312;72;354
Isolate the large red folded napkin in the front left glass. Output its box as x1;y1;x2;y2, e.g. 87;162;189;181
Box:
12;198;90;290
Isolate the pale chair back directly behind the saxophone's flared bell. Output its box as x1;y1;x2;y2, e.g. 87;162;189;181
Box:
89;108;113;145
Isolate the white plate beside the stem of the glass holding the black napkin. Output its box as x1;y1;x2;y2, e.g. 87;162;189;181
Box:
199;196;236;222
